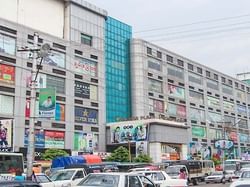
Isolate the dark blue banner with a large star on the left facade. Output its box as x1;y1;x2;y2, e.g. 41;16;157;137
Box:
75;106;98;124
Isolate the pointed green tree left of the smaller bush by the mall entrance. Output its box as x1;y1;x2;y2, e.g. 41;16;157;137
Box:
107;146;129;162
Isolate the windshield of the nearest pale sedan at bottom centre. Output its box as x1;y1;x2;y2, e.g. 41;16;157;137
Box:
78;174;120;187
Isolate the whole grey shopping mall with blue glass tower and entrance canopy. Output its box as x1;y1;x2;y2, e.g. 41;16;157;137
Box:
0;0;250;161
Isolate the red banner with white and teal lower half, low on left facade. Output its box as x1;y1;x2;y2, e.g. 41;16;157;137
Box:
44;131;65;149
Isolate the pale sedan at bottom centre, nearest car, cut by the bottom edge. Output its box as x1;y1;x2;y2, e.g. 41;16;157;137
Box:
77;173;156;187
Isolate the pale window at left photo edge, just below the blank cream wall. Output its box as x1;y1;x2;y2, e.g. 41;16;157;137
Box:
0;34;16;55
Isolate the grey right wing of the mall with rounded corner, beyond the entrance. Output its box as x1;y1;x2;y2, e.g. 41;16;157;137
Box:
131;39;250;159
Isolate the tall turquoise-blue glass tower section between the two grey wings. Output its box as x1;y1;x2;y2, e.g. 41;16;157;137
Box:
105;17;132;123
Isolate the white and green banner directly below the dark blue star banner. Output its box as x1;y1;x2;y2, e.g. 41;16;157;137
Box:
74;132;98;153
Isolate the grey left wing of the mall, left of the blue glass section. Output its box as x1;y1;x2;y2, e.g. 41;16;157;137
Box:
0;0;107;156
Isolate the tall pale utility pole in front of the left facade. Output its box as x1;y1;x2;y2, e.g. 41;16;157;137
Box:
27;33;39;178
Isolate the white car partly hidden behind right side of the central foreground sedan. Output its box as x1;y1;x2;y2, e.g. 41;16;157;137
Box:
133;170;188;187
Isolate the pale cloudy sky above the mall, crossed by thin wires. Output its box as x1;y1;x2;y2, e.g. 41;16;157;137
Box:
87;0;250;77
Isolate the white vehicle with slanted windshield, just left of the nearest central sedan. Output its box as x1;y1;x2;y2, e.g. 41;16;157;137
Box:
50;168;87;187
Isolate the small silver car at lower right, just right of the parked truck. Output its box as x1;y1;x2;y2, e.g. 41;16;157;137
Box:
205;171;232;184
